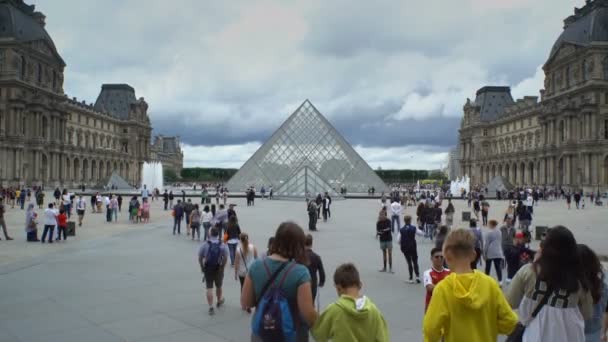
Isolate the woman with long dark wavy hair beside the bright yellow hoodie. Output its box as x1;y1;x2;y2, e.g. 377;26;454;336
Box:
508;226;593;342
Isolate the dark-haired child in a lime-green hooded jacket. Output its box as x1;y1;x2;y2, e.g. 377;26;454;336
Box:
311;264;389;342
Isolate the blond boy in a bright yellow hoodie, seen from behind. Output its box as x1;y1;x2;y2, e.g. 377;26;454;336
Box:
423;229;516;342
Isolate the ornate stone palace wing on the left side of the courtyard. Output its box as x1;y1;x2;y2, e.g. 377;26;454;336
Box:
0;0;152;187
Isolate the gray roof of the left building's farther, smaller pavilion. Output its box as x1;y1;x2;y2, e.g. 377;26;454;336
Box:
95;84;137;120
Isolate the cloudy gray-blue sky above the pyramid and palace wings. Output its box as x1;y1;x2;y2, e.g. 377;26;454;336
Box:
35;0;572;169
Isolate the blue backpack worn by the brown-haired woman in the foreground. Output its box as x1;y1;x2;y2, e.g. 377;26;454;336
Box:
251;260;296;342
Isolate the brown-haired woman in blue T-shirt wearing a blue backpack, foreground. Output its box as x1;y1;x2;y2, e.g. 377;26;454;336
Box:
241;222;318;342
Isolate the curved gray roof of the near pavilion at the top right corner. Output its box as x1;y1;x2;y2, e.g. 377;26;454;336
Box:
549;0;608;60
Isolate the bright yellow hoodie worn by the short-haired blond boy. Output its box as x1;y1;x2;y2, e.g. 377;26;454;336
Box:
422;270;517;342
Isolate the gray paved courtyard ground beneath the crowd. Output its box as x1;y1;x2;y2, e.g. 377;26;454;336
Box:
0;196;608;342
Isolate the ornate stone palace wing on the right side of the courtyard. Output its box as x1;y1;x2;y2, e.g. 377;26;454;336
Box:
459;0;608;191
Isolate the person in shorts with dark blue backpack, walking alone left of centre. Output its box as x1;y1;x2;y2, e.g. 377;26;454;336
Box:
198;228;228;315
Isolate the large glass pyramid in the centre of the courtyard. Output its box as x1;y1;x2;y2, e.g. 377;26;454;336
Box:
227;100;387;198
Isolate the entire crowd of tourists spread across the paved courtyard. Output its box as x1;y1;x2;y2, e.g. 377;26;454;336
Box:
0;187;608;342
